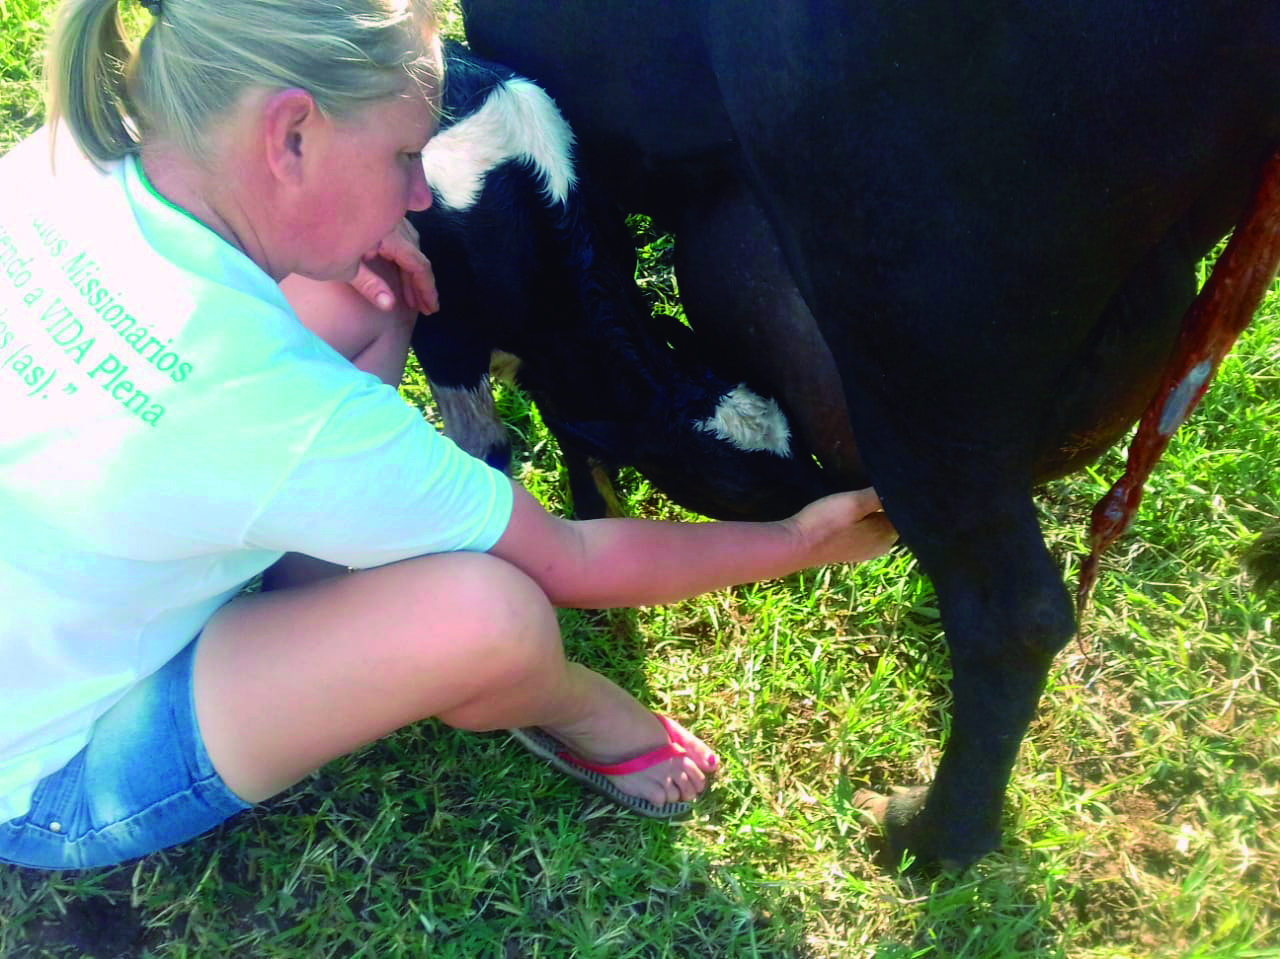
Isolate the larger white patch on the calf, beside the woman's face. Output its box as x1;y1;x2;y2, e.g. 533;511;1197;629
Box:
422;79;577;210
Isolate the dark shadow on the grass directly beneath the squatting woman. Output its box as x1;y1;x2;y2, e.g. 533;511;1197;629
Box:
0;742;806;959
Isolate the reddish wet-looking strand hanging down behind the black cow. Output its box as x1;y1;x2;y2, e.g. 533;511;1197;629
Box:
1075;151;1280;615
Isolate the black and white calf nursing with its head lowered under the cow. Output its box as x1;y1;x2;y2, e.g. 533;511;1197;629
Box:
411;46;832;519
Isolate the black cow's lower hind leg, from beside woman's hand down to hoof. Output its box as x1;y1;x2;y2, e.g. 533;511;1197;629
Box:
868;481;1073;867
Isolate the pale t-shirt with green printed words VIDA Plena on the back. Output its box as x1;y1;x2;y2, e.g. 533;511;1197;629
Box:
0;129;512;822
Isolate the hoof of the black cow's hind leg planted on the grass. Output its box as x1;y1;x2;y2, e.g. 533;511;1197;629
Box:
854;786;1000;872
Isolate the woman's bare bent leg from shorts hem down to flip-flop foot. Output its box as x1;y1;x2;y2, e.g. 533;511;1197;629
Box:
193;553;714;804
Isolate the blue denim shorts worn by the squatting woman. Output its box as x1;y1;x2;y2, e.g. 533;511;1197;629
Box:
0;641;250;869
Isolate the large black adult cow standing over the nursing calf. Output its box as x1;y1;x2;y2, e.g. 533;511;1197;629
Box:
453;0;1280;863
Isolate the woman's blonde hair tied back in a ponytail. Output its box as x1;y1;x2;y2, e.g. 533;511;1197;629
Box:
45;0;440;163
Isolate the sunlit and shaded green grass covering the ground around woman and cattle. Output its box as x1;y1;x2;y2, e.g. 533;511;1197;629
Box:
0;0;1280;959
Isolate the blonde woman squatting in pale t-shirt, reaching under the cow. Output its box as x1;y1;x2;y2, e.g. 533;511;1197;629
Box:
0;0;895;868
